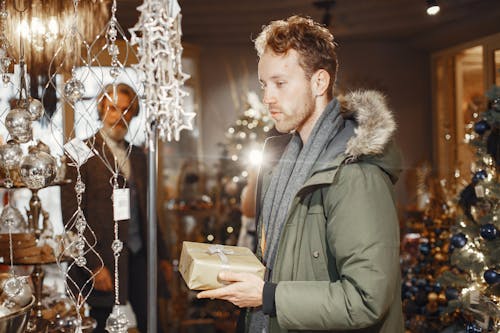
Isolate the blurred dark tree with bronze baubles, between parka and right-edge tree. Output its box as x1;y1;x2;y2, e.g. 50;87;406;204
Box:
401;164;462;333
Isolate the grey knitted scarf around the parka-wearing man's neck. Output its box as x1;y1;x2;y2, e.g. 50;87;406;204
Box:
250;99;354;333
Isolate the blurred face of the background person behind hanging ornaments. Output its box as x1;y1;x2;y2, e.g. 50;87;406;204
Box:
101;93;134;141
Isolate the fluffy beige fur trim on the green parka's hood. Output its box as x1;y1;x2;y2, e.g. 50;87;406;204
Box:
338;90;396;159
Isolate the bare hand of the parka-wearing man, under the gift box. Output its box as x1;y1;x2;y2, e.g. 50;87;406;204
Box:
197;271;264;308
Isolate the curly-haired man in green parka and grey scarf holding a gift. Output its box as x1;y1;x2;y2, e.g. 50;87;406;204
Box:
198;16;403;333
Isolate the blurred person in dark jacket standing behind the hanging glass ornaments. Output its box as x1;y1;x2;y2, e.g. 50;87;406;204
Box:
61;83;168;332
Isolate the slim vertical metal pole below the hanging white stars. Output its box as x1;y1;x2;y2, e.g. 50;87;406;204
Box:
146;123;158;333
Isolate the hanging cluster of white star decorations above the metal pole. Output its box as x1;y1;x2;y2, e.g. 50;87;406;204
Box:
130;0;196;145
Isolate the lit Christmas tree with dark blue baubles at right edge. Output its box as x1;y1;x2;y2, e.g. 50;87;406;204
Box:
437;87;500;333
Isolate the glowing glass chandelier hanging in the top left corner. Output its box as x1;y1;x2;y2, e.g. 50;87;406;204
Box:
5;0;111;77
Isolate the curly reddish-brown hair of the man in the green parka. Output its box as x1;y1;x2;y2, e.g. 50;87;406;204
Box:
255;15;338;97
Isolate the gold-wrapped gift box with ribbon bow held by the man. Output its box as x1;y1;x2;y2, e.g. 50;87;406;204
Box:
179;242;265;290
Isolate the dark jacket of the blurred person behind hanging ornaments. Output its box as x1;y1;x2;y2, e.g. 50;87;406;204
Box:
61;133;166;307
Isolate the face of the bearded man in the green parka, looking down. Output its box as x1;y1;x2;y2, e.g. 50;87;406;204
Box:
258;50;315;133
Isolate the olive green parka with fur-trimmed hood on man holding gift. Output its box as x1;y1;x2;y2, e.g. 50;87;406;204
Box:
257;91;404;333
